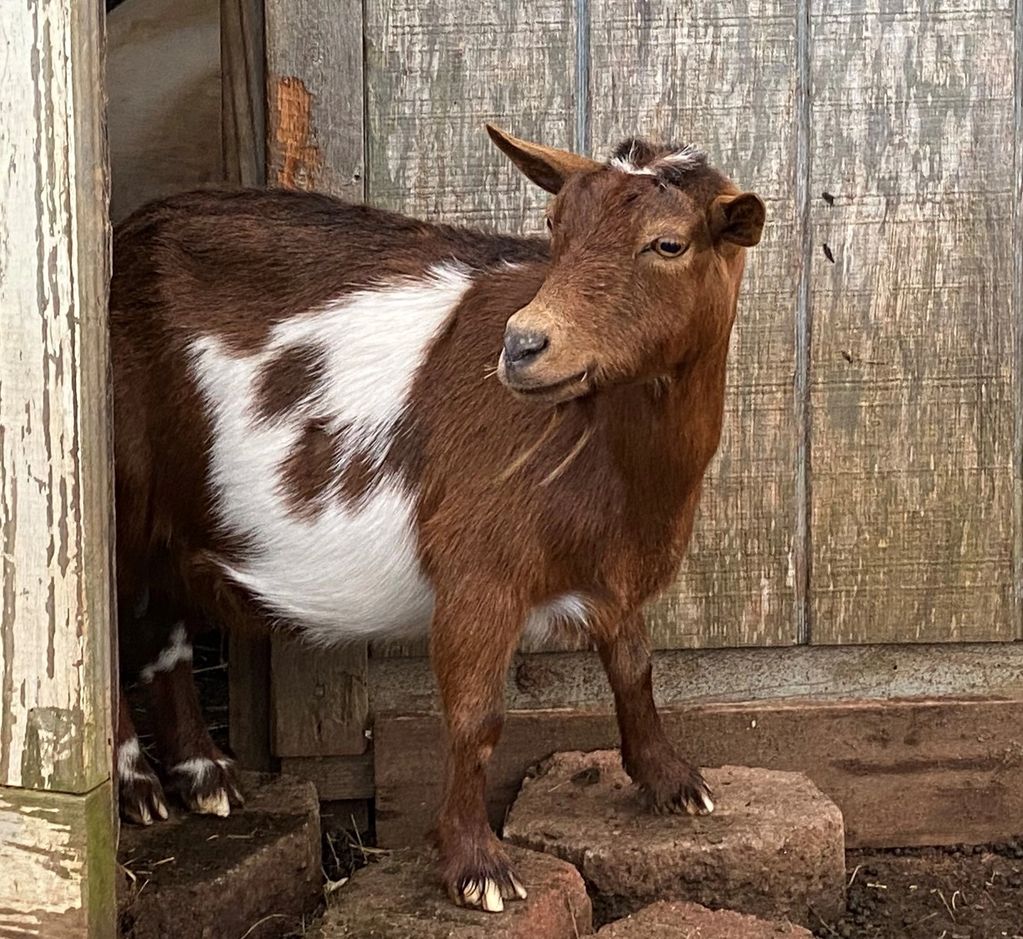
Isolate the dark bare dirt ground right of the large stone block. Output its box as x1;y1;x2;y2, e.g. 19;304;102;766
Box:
814;839;1023;939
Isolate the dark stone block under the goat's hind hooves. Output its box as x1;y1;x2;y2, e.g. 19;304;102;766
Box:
118;772;322;939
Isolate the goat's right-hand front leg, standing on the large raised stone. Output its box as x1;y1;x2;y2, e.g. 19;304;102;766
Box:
594;614;714;815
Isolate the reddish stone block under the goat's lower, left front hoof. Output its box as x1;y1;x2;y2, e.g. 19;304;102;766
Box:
307;847;592;939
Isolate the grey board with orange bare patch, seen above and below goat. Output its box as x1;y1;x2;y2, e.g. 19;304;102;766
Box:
265;0;368;756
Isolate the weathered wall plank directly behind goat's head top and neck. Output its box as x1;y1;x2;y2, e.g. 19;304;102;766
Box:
590;0;801;647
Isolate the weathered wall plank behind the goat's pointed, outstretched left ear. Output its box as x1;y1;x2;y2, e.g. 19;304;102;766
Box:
365;0;576;232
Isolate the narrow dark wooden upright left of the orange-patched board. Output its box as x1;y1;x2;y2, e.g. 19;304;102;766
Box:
220;0;266;186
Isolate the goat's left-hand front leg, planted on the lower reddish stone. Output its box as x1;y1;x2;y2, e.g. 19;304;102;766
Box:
431;595;526;912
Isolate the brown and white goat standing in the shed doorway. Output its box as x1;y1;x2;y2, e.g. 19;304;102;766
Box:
110;129;764;910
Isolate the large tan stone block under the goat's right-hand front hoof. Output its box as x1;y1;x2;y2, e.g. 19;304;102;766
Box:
504;751;845;927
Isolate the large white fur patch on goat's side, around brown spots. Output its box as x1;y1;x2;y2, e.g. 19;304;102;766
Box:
192;265;472;643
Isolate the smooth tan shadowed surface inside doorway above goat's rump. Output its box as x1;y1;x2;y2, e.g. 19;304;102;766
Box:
106;0;224;222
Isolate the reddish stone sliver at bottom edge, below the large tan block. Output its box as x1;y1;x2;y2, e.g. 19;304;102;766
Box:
596;900;813;939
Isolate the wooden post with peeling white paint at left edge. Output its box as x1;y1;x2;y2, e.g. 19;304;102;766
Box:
0;0;116;939
